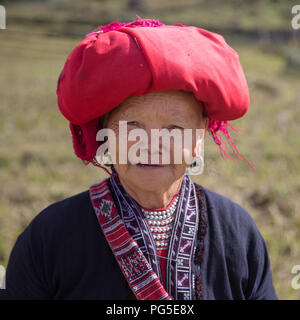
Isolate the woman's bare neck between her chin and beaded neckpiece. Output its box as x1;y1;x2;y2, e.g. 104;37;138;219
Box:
119;177;183;210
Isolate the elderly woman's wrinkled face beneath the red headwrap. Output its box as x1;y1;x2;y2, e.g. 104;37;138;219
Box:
106;90;207;191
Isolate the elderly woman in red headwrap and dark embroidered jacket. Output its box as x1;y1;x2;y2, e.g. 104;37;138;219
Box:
0;19;277;300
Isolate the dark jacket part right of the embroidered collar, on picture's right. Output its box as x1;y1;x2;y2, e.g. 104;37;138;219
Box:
201;188;277;300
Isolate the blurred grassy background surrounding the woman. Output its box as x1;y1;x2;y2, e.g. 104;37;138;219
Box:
0;0;300;299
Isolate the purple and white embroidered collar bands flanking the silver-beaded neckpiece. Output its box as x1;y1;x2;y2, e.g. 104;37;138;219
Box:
109;174;199;300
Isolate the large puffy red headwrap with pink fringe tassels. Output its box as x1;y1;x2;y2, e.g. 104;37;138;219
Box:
57;19;253;168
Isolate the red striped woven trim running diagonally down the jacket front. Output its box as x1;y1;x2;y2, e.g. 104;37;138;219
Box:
89;179;171;300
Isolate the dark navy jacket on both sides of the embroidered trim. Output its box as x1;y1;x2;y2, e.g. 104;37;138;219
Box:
0;187;277;300
